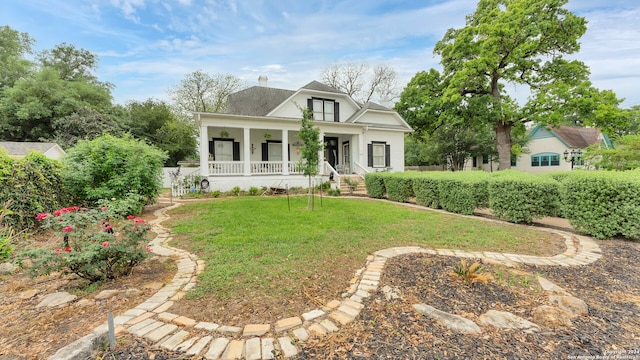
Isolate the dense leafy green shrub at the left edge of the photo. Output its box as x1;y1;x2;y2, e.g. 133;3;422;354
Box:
0;151;69;229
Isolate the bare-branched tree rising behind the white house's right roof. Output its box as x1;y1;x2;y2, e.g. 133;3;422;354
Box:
321;62;399;105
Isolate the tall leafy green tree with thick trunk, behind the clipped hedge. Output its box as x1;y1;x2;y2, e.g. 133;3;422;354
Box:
434;0;619;169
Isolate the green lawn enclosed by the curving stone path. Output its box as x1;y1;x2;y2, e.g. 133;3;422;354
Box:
167;196;558;299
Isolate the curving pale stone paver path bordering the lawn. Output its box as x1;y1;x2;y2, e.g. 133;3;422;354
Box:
49;203;602;360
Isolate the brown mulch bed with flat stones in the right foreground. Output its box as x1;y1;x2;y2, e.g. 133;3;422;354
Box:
298;240;640;359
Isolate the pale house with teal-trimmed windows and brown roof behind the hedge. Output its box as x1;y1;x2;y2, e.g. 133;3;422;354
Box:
471;125;613;173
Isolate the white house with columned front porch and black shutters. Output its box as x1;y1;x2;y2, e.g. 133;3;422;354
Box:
194;81;412;191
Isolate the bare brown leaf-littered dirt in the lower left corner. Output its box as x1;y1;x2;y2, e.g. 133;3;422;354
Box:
0;205;176;359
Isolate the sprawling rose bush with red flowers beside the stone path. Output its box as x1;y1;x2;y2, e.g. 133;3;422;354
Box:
21;206;151;282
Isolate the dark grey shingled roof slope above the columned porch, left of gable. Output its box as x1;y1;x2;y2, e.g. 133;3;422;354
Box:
226;86;295;116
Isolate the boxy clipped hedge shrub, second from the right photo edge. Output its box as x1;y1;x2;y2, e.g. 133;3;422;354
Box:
489;171;560;223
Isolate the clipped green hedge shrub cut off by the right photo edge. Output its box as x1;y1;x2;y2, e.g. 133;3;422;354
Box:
562;170;640;239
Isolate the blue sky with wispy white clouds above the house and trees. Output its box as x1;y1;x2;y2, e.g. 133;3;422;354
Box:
0;0;640;107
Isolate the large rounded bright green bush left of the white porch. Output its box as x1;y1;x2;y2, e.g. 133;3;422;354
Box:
64;135;167;206
